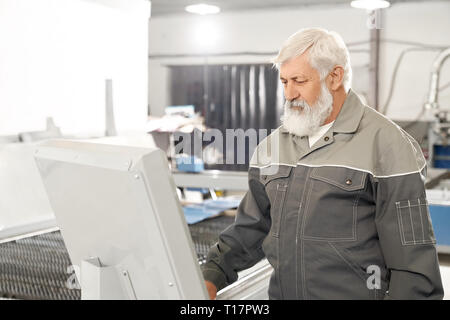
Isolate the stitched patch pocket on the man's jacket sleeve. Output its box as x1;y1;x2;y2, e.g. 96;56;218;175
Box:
395;198;436;246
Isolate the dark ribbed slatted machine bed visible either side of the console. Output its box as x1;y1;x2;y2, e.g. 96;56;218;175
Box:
0;215;234;300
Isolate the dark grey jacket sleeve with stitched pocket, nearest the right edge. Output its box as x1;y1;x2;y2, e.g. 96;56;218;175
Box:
375;162;444;299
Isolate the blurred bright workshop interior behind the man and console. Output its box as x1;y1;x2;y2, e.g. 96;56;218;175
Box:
0;0;450;299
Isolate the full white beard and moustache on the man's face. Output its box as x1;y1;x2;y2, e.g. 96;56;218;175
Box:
281;82;333;137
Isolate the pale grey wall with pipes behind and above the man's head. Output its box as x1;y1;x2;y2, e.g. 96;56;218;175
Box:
149;1;450;120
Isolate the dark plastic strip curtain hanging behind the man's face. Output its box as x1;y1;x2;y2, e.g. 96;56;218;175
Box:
170;64;283;170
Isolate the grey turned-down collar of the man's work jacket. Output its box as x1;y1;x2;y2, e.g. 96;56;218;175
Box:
280;89;364;133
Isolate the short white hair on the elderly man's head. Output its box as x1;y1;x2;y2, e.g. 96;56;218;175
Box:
272;28;352;92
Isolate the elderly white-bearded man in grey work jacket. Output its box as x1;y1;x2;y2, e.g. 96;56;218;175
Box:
202;28;443;299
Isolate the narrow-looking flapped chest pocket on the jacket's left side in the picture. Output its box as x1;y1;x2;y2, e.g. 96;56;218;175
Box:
261;166;292;238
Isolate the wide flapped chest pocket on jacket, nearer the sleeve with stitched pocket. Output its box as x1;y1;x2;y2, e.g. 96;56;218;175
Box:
302;166;368;242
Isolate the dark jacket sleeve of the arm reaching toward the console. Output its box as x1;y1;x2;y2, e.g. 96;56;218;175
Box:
201;167;271;290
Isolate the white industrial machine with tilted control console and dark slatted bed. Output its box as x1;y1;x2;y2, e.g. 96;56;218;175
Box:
0;140;272;299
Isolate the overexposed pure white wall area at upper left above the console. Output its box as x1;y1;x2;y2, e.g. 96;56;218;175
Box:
0;0;150;136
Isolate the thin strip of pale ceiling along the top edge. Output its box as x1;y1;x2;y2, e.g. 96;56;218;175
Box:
151;0;434;16
